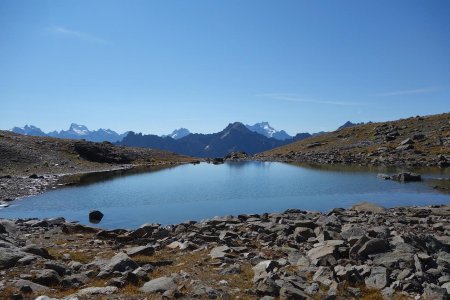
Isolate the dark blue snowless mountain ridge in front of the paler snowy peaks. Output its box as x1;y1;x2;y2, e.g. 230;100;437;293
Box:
119;122;292;157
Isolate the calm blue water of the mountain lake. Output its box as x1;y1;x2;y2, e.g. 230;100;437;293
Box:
0;162;450;228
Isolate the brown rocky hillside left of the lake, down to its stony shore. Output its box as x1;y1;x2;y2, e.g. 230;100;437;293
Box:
0;131;193;206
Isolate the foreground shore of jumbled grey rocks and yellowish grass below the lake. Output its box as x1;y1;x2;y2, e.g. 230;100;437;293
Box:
0;203;450;300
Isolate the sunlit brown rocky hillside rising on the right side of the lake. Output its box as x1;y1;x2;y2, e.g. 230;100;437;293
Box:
255;113;450;167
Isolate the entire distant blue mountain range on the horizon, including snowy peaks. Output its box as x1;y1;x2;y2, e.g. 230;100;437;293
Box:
11;122;358;157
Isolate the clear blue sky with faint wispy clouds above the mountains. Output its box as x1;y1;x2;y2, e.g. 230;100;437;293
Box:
0;0;450;134
